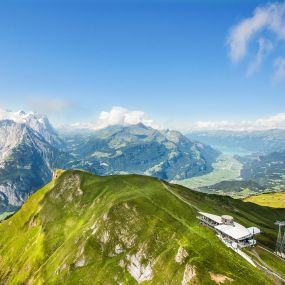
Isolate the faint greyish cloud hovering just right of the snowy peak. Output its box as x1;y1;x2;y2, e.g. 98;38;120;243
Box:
27;96;74;115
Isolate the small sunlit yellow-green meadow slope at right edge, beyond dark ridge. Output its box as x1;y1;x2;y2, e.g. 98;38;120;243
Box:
245;192;285;207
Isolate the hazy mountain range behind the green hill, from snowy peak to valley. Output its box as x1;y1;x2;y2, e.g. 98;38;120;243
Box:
0;111;218;212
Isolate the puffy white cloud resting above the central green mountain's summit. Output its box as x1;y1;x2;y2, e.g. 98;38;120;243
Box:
73;107;159;130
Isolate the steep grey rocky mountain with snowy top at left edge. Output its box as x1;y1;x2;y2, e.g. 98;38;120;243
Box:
0;111;66;211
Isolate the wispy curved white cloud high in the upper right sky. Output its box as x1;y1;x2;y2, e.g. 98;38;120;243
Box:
227;2;285;77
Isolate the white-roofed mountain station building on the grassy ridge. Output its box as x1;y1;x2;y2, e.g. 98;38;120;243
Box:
197;212;260;248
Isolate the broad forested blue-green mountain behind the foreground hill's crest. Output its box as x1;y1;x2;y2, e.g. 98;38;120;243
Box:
64;124;218;180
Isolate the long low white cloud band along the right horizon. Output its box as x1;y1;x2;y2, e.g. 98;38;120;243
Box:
193;113;285;131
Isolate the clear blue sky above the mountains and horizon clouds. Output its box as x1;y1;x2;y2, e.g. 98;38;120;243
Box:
0;0;285;128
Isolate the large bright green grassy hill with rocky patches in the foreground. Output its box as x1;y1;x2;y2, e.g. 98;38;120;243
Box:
0;171;281;284
